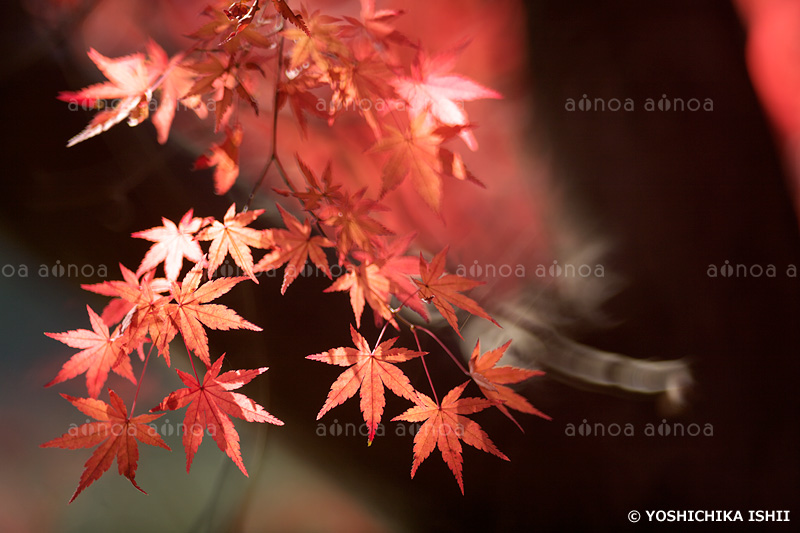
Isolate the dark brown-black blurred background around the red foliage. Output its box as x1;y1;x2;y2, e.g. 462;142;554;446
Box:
0;1;800;531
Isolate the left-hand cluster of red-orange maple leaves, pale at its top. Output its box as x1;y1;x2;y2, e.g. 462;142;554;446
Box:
43;205;283;501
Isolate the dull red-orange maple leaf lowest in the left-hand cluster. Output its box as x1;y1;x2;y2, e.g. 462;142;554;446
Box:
40;389;170;503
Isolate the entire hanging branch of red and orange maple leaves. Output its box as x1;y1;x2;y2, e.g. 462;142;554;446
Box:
42;0;549;501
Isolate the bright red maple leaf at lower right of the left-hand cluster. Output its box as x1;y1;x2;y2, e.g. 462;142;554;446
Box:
151;354;283;476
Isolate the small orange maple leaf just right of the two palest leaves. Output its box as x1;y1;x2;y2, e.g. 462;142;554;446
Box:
255;205;333;294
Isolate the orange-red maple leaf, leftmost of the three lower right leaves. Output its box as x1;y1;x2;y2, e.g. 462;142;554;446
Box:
306;325;427;444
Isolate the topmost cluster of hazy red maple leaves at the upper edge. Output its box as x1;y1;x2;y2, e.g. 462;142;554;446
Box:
59;0;501;212
